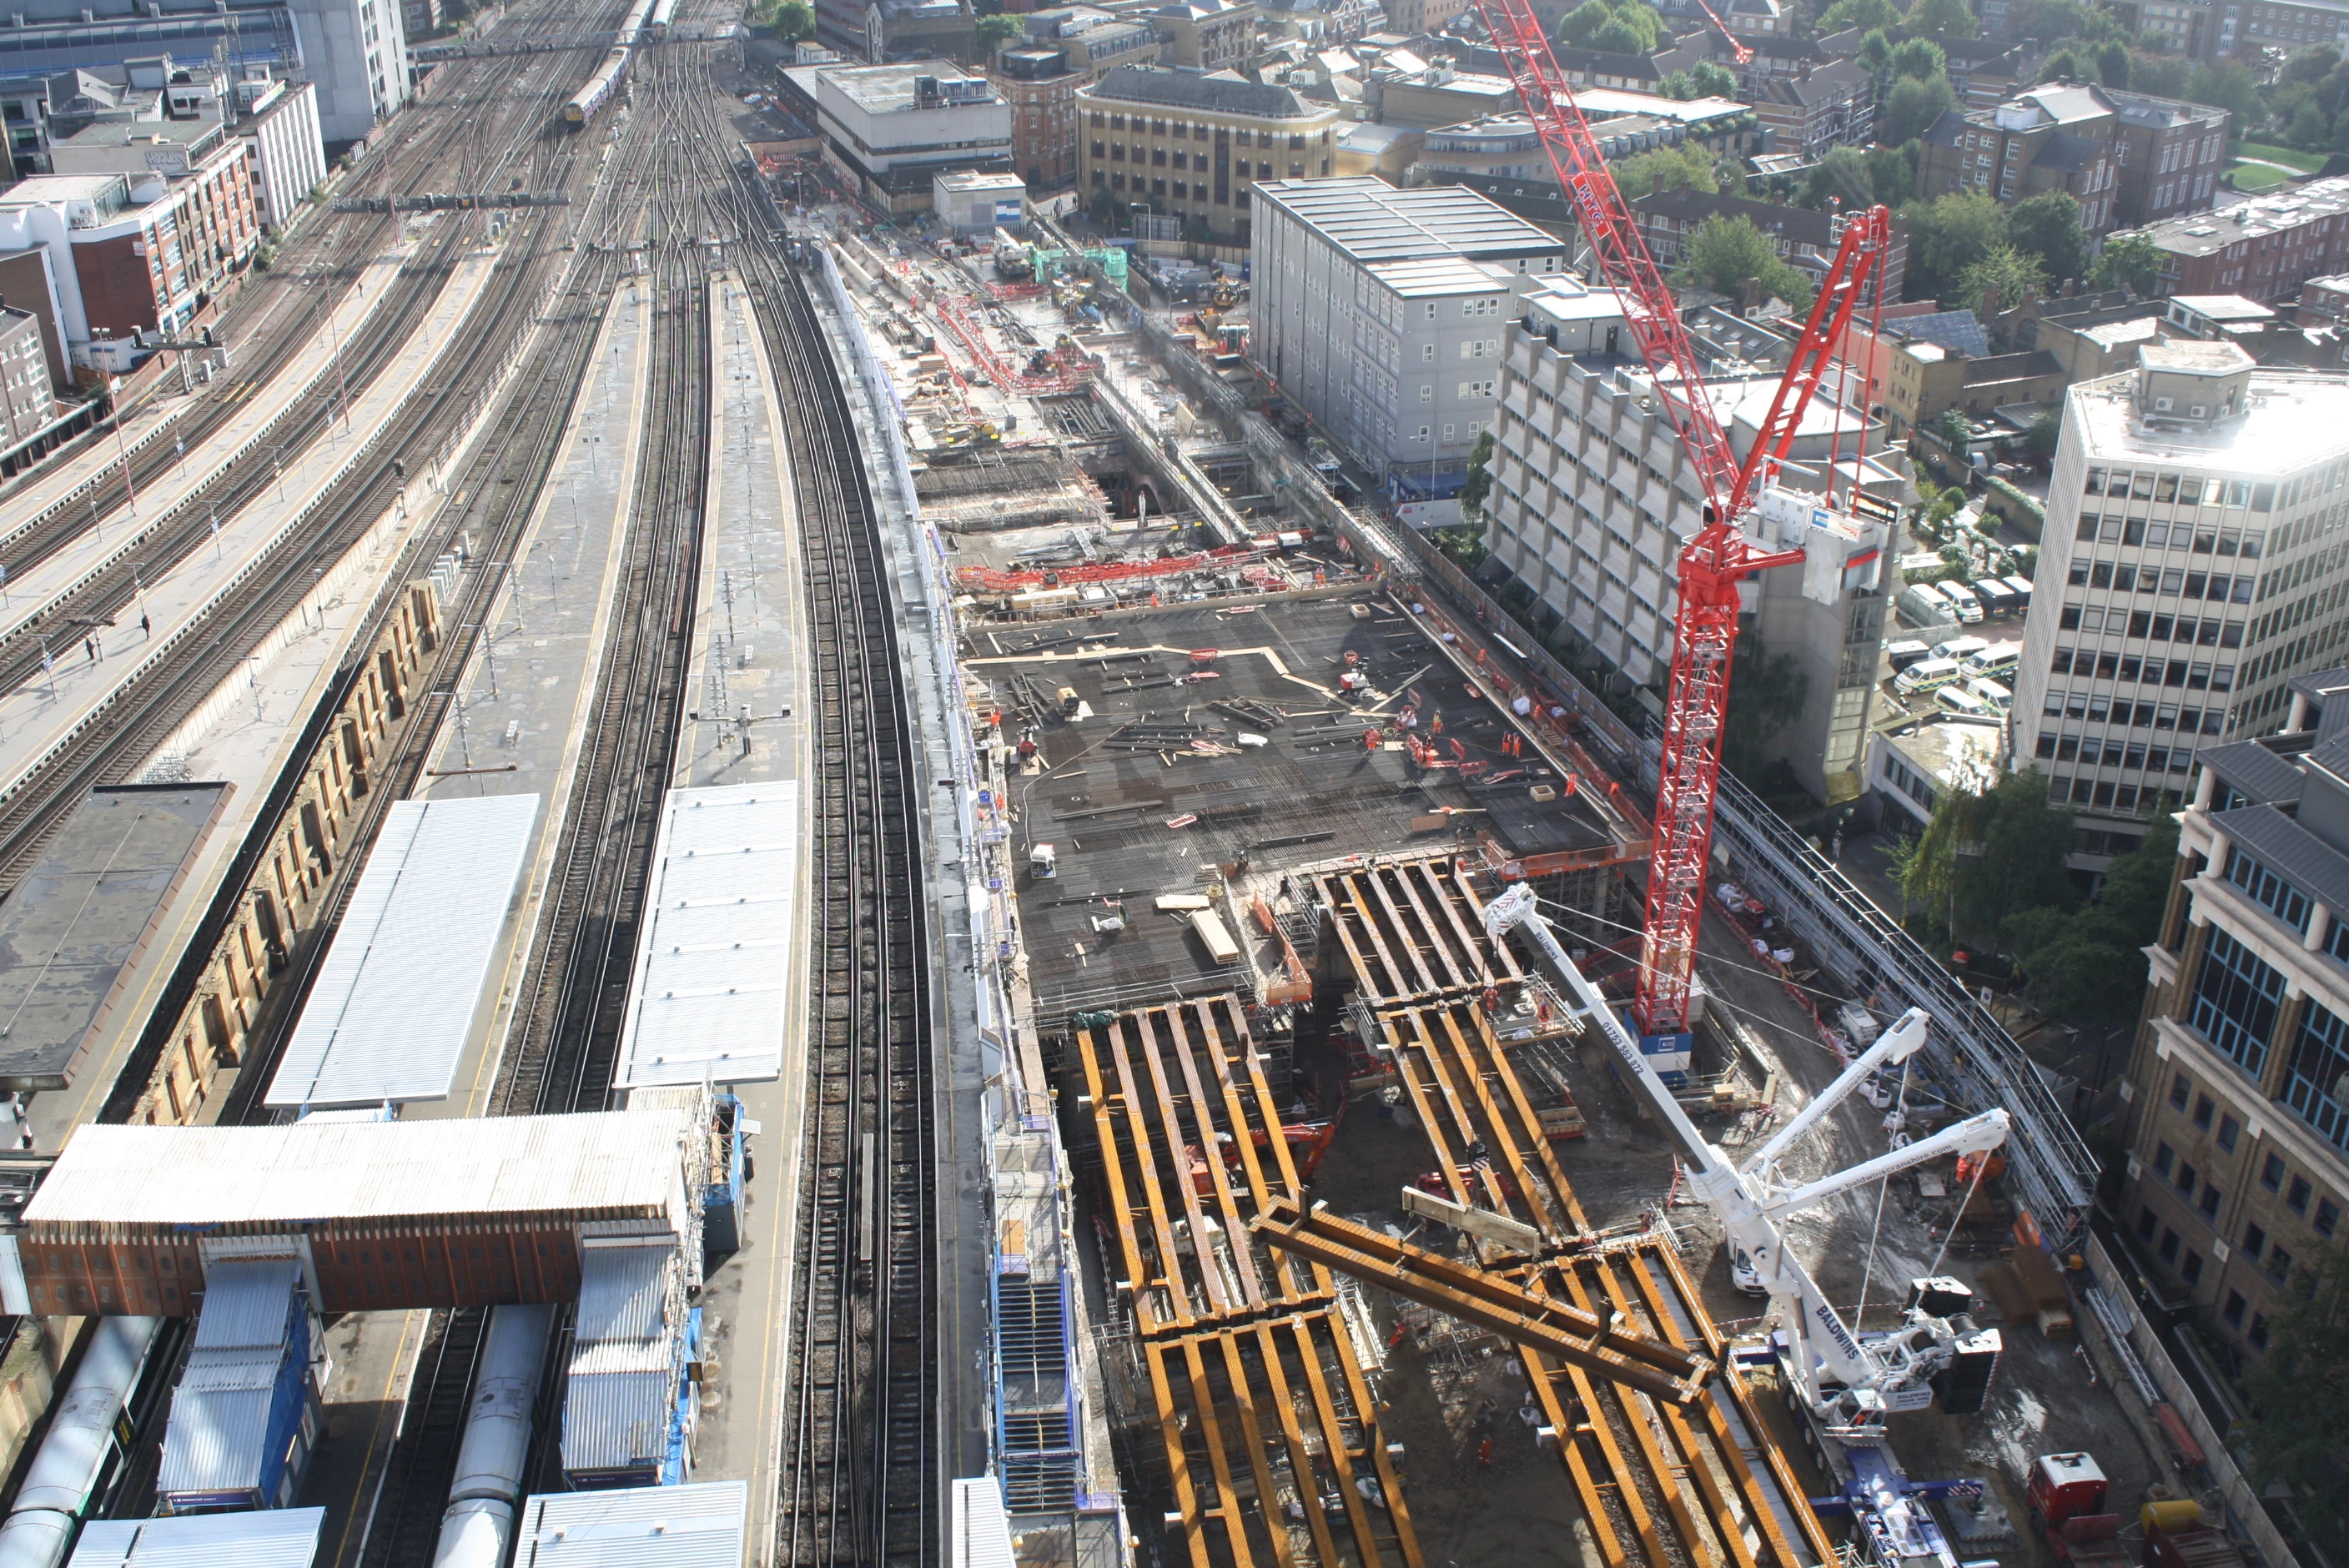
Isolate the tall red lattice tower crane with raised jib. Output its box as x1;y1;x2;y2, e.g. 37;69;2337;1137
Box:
1473;0;1891;1035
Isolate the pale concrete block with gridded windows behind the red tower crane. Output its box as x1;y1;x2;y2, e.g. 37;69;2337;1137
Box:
1485;277;1903;801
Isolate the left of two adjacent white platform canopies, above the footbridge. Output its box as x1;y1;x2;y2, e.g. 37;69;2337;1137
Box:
263;796;538;1106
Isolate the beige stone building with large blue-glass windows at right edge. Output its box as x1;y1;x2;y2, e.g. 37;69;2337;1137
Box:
2119;669;2349;1354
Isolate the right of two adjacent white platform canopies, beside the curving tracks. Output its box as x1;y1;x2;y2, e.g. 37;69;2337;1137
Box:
618;779;798;1089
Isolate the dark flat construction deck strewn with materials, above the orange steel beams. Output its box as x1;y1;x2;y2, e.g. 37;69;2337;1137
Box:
982;594;1626;1021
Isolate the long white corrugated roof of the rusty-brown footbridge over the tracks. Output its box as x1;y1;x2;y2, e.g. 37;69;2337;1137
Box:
26;1110;691;1233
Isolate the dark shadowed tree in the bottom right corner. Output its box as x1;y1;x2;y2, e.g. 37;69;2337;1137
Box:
2243;1242;2349;1542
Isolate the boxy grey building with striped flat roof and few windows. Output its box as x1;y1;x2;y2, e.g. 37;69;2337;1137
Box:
1247;178;1567;498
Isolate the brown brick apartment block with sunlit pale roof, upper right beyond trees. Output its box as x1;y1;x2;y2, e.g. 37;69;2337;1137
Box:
1917;84;2121;234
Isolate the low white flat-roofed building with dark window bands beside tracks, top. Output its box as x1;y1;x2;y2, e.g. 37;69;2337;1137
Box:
782;61;1013;214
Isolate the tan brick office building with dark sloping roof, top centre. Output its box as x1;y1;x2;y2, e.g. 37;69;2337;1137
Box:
1076;66;1336;247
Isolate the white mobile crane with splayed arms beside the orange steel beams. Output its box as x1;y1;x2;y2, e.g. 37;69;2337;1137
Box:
1485;882;2006;1441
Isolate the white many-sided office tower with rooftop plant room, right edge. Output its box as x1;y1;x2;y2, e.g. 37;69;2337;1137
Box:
2013;340;2349;871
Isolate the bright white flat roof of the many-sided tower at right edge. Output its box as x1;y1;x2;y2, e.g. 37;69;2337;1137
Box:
2067;368;2349;476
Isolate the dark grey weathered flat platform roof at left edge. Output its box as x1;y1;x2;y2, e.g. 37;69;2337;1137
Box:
0;784;230;1093
